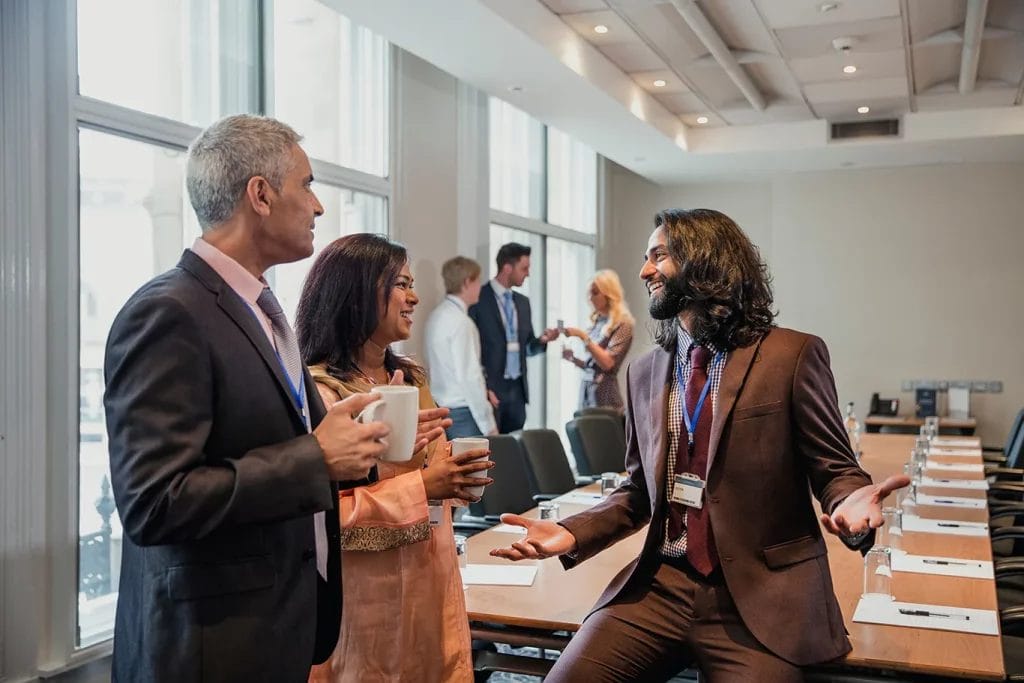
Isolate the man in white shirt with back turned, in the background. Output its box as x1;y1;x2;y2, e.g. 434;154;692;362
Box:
426;256;498;438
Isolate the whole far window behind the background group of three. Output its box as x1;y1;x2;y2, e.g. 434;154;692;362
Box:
488;98;597;448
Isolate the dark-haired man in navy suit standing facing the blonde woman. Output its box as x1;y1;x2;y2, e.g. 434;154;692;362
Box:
469;242;558;434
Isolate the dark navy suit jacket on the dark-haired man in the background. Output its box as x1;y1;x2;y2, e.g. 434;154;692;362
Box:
469;283;547;402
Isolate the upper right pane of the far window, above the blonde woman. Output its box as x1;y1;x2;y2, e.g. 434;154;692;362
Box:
548;128;597;234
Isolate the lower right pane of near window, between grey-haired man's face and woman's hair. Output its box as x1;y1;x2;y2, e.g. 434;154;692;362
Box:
268;185;387;322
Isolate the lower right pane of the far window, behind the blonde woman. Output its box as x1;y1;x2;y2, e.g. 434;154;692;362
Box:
546;238;594;456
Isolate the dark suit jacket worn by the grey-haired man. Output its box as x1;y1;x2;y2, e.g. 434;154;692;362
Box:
103;251;341;683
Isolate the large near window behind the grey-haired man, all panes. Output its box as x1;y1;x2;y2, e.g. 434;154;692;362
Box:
75;0;391;646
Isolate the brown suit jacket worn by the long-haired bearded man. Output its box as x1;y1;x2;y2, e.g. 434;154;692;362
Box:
562;329;871;666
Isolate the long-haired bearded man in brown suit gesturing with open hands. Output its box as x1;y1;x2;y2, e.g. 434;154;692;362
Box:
492;209;908;683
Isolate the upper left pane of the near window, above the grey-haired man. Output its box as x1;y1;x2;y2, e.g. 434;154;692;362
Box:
78;0;260;126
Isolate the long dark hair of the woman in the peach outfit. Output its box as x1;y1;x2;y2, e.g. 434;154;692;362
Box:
295;233;426;385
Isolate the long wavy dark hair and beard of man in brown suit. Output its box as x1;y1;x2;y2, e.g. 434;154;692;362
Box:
654;209;775;350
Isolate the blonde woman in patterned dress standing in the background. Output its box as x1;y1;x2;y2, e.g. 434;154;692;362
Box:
562;270;634;411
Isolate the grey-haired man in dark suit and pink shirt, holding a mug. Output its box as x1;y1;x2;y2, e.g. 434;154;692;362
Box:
104;116;388;683
